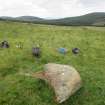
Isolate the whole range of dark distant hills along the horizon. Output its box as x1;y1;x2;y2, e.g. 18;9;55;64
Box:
0;12;105;26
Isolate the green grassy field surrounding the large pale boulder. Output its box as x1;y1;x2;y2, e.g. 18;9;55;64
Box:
0;22;105;105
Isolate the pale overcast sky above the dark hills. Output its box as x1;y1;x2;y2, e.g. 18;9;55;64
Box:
0;0;105;18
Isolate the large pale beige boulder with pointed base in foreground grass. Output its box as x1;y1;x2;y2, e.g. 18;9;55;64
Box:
31;63;82;103
